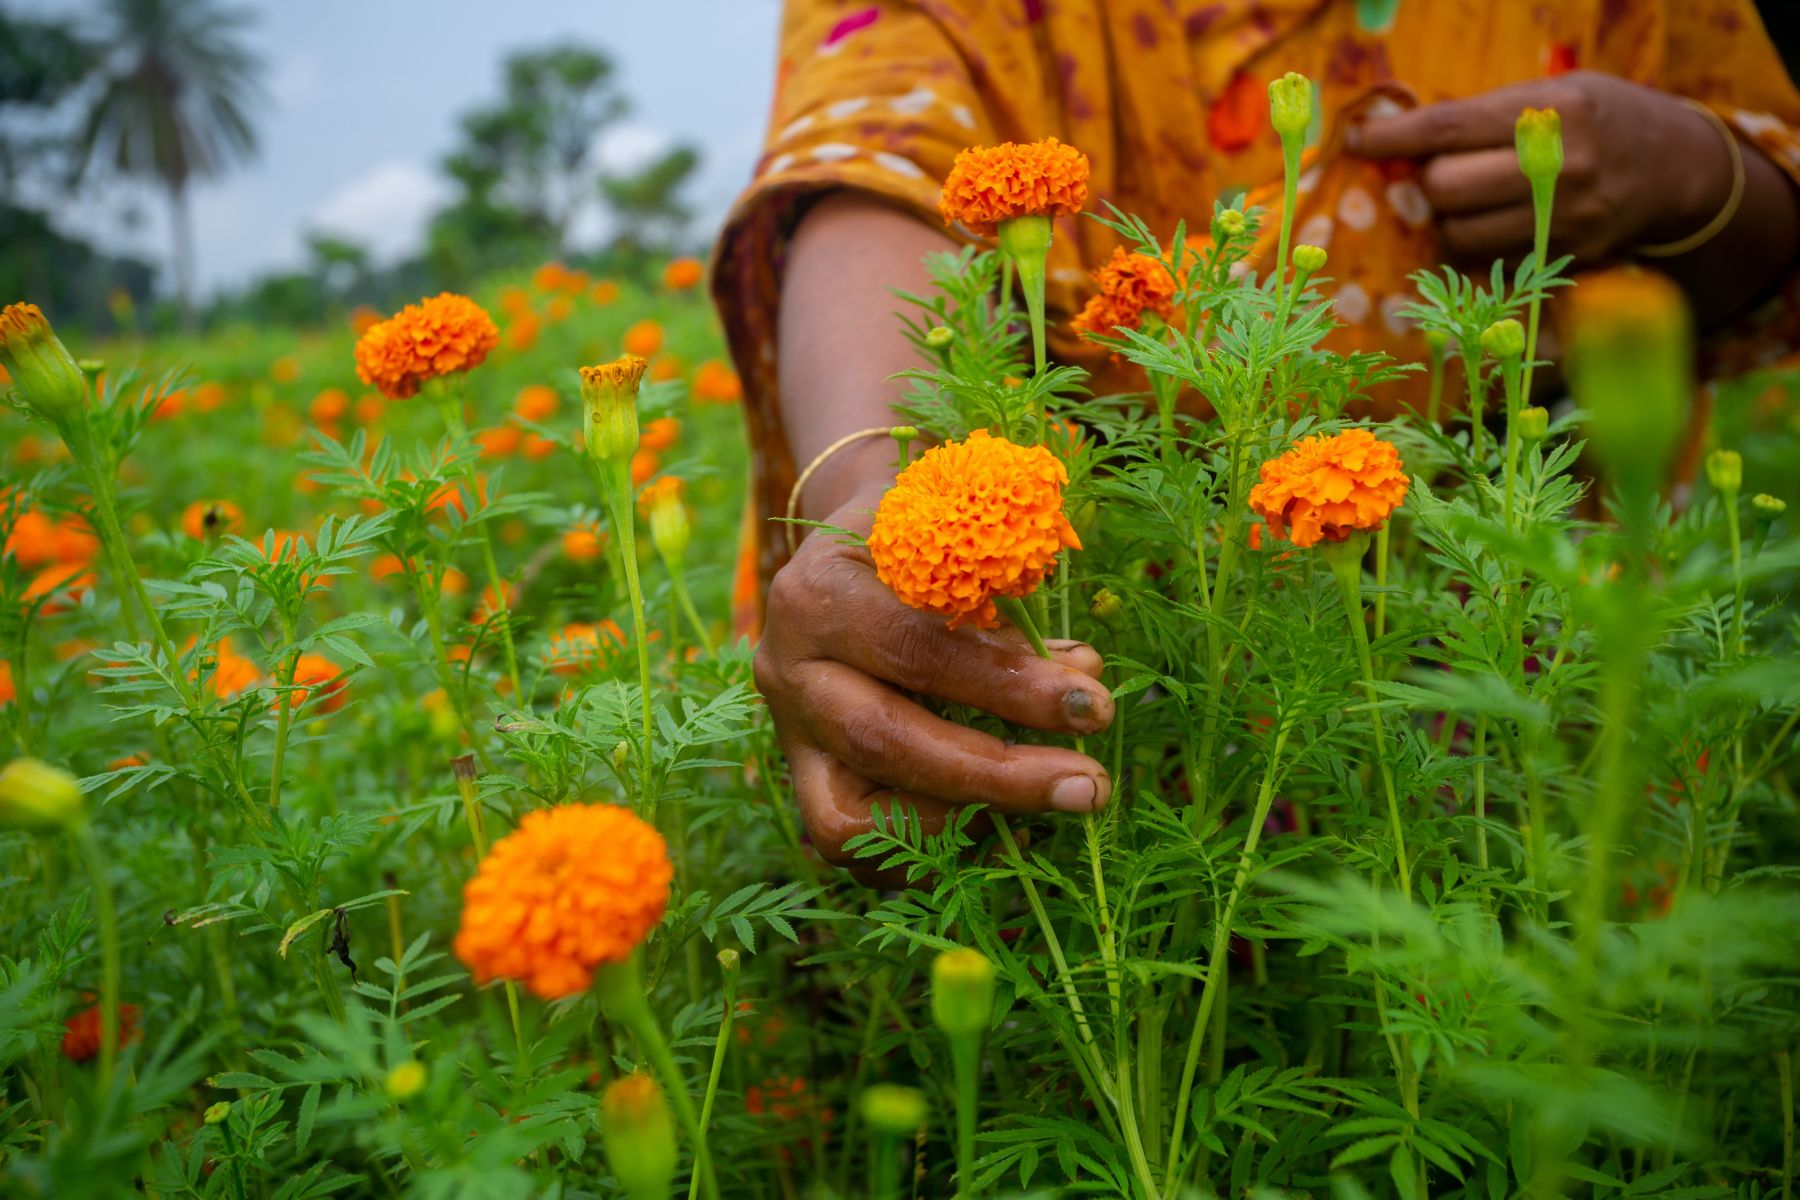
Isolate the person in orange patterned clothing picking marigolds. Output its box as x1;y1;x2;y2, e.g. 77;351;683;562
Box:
715;0;1800;877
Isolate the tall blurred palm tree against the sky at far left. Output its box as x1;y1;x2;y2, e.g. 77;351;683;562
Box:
79;0;263;315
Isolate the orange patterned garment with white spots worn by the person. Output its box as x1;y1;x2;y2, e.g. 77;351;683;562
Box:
713;0;1800;628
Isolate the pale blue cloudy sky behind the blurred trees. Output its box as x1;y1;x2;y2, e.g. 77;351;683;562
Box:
0;0;781;291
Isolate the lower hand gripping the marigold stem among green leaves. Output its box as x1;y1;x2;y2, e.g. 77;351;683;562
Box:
756;484;1112;882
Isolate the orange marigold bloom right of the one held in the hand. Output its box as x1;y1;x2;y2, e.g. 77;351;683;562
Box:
1249;428;1408;547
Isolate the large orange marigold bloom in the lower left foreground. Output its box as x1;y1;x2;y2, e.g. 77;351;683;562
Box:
455;804;673;1000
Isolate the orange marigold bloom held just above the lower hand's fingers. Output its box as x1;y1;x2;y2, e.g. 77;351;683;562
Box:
869;430;1082;630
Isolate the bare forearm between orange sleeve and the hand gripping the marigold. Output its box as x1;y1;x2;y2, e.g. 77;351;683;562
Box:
778;191;956;518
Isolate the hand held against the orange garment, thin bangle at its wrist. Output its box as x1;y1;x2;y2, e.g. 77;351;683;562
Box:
1348;70;1732;266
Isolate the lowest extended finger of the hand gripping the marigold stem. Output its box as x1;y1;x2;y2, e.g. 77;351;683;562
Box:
796;662;1112;813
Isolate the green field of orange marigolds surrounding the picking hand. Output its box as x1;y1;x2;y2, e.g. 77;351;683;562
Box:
0;76;1800;1200
